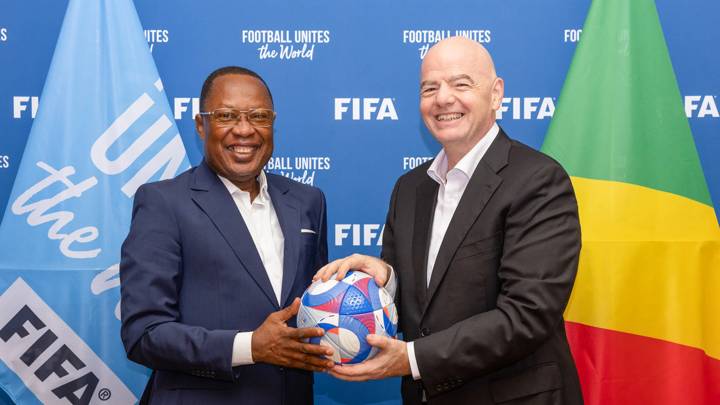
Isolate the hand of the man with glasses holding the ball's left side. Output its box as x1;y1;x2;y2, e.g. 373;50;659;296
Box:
251;298;335;371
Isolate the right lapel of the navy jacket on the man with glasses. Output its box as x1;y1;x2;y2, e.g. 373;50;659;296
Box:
267;175;300;306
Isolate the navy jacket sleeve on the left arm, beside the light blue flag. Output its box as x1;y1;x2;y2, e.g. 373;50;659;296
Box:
120;185;237;380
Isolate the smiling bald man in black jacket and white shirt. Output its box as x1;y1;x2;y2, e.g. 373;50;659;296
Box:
316;37;582;405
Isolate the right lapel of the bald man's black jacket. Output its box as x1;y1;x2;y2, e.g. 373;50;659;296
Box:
423;129;510;314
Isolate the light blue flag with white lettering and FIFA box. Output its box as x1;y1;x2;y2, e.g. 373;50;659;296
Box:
0;0;189;404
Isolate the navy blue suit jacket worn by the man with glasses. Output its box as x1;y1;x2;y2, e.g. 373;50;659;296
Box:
120;162;327;405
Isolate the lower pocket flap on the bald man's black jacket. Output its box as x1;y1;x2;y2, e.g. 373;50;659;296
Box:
490;363;562;405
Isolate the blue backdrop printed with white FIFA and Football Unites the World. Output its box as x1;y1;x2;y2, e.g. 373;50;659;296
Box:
0;0;720;404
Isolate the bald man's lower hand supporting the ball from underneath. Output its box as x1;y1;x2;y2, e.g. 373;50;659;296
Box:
330;334;410;381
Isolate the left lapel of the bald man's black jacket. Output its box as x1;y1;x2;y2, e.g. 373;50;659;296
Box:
412;176;439;308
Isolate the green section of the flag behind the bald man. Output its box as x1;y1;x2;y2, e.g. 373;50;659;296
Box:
542;0;712;206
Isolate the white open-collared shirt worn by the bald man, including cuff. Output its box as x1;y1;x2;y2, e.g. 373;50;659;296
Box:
404;124;500;380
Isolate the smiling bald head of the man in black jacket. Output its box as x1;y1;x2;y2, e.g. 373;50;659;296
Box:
420;37;504;168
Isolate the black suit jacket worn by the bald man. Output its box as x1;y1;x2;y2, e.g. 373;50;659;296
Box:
383;130;582;404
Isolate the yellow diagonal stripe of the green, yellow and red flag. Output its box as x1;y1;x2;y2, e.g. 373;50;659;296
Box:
565;177;720;359
